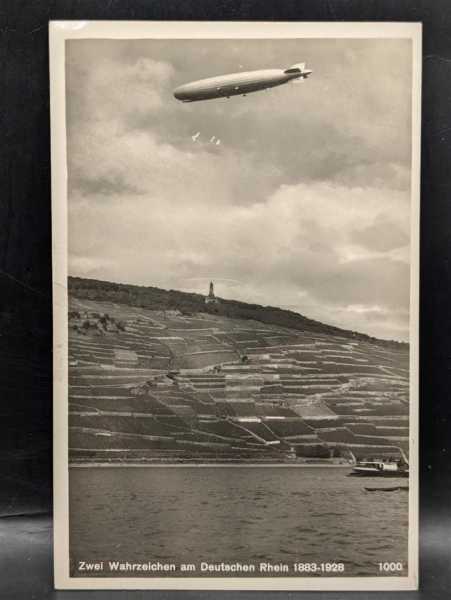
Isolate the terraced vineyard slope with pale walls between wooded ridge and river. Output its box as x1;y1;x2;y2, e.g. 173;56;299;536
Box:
69;296;409;463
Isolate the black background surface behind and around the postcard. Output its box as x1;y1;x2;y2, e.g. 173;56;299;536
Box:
0;0;451;600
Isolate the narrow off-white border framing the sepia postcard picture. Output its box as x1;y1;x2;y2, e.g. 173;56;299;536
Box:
49;21;422;591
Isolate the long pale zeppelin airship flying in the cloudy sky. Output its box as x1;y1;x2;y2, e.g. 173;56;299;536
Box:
174;63;312;102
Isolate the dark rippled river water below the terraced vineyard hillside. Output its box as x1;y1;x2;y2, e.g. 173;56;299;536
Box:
70;466;408;577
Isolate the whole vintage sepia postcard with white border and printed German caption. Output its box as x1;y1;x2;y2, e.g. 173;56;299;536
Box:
50;21;421;590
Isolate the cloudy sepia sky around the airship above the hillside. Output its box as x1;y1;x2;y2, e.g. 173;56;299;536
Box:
66;39;411;340
